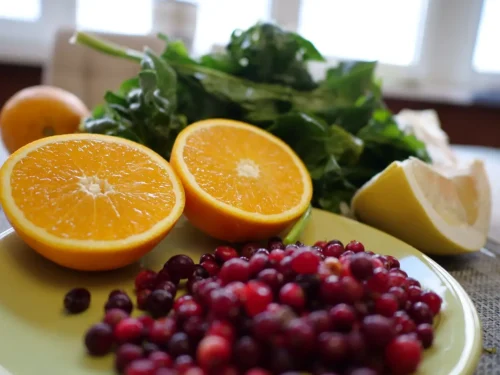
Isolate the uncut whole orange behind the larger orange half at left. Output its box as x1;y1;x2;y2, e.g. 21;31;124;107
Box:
0;85;89;153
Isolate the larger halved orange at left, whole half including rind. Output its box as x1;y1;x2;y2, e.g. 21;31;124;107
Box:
0;134;185;271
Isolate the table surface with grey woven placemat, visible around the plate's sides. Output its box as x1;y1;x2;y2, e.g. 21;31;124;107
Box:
0;146;500;375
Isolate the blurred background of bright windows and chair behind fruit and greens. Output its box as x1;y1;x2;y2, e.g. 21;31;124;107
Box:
0;0;500;147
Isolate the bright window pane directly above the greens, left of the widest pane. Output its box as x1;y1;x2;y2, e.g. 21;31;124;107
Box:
193;0;270;54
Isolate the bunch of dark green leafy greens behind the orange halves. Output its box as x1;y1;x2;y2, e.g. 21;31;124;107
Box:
73;23;429;212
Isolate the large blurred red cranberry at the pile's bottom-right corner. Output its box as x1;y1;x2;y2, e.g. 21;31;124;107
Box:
385;335;422;375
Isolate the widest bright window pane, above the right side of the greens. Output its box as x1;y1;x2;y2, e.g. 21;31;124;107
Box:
299;0;427;65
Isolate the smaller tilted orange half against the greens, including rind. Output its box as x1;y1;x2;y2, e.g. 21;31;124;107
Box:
170;119;312;242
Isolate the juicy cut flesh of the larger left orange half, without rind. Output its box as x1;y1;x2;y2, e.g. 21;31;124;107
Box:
11;140;176;241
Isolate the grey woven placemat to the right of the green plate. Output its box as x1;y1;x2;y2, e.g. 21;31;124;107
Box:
433;242;500;375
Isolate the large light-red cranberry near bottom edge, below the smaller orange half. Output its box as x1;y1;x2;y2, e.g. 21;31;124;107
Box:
196;336;232;370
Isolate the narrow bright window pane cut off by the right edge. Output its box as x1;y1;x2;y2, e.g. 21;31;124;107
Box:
473;0;500;73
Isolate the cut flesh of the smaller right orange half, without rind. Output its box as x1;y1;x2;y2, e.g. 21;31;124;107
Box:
183;125;304;215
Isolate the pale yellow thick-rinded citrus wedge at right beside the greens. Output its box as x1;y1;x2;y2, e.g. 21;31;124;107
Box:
352;158;491;255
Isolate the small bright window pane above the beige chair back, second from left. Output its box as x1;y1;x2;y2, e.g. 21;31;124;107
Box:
76;0;153;34
